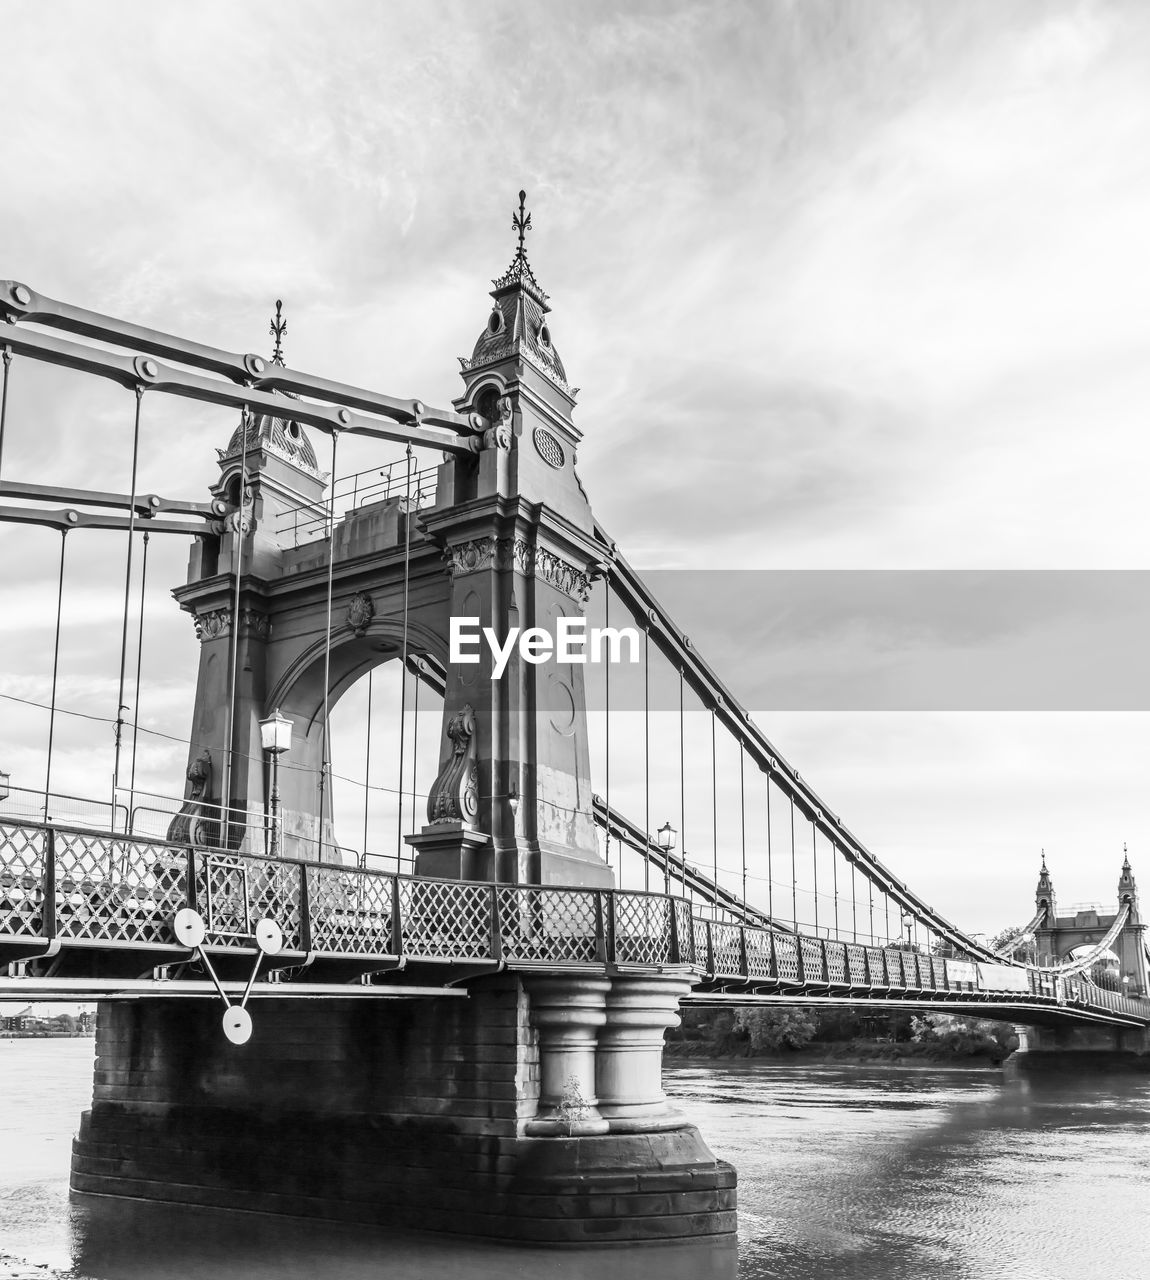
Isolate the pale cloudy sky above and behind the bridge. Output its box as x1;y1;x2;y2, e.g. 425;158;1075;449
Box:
0;0;1150;932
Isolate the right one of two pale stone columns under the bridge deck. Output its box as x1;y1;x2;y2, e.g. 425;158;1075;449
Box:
595;973;693;1133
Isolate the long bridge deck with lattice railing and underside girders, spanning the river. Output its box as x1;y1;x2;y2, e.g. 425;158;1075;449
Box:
0;822;1150;1027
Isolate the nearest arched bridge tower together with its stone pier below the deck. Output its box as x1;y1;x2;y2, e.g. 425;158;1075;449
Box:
72;192;735;1243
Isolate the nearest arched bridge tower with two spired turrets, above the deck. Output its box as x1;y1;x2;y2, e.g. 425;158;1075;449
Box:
174;193;613;887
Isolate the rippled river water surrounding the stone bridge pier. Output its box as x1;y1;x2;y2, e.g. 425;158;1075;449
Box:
0;1039;1150;1280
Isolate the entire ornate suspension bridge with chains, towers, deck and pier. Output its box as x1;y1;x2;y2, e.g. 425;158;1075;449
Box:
0;193;1150;1242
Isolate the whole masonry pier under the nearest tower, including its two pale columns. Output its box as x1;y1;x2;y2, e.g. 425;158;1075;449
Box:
72;972;735;1244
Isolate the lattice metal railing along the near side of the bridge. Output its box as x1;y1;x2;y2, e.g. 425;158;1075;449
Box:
0;820;1150;1023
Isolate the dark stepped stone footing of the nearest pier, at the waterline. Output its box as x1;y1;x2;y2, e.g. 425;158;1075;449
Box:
72;1105;736;1244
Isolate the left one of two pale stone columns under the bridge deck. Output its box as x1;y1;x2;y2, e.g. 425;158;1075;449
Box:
524;974;611;1138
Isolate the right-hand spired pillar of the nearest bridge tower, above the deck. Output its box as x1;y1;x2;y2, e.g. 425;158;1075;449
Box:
409;192;613;887
